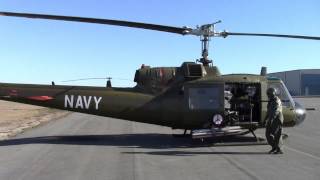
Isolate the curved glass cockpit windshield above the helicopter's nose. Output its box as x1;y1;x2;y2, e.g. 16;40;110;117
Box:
268;81;294;107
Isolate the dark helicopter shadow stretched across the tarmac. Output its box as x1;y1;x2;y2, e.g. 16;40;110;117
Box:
0;133;265;156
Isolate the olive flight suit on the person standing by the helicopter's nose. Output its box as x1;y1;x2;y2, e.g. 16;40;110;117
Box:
266;95;283;153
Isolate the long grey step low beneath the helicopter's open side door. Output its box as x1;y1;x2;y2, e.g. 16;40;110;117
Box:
191;126;250;139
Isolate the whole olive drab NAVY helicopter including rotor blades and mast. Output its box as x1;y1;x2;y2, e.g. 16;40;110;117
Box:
0;12;320;138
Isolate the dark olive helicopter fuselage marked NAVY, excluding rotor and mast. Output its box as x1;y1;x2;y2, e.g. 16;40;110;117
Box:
0;63;305;129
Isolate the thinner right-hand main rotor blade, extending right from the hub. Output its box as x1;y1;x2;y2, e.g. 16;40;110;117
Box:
221;31;320;40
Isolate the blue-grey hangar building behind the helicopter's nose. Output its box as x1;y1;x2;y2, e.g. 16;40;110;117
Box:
268;69;320;96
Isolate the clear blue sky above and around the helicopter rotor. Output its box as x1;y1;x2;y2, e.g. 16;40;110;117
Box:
0;0;320;87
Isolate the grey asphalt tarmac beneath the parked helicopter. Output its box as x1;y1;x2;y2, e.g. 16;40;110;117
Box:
0;98;320;180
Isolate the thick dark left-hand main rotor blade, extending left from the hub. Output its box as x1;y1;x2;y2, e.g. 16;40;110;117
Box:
0;12;189;35
